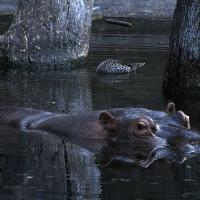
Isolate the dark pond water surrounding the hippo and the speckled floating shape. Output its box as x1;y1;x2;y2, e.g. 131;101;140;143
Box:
0;20;200;200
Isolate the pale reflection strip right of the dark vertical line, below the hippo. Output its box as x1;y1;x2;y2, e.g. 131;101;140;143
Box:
65;143;101;200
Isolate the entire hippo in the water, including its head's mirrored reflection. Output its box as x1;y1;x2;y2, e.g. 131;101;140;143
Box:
0;103;200;167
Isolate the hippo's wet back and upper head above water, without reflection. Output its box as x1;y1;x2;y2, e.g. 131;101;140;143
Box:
0;105;197;145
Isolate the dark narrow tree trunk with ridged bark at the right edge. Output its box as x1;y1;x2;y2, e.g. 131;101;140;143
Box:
163;0;200;100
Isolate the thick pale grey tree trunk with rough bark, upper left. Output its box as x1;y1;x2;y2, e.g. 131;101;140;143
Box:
0;0;93;66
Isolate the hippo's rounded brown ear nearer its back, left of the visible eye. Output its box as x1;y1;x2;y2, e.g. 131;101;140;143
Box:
99;112;117;131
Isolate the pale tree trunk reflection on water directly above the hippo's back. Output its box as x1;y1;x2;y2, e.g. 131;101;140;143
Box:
0;69;92;113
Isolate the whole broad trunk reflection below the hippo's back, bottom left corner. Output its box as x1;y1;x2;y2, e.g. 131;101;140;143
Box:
0;127;101;200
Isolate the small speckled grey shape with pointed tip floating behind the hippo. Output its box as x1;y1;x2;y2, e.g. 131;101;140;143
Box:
96;59;145;74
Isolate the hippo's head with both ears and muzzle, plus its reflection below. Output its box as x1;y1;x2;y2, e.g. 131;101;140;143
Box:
99;105;200;167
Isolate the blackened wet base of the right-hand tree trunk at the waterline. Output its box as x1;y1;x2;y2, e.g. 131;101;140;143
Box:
162;61;200;100
